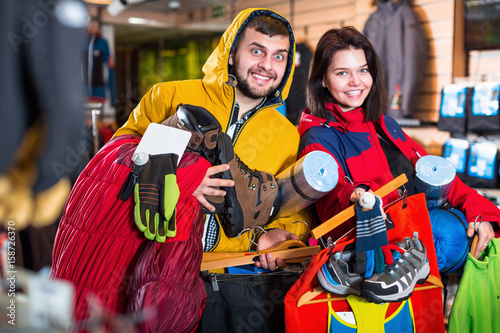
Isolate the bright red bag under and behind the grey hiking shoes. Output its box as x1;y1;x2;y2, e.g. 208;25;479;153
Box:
285;194;445;333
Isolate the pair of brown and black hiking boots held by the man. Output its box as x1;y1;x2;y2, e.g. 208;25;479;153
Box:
162;104;279;237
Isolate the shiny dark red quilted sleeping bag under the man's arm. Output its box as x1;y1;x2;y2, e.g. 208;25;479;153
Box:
51;135;210;330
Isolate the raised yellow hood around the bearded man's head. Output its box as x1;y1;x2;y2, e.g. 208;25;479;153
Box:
202;8;295;105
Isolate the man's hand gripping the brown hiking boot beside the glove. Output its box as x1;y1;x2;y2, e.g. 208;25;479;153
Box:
193;164;234;212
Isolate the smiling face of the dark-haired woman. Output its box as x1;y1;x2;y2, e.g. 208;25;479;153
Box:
323;49;373;112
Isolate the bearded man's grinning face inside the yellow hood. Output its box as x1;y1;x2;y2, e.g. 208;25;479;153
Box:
229;29;290;99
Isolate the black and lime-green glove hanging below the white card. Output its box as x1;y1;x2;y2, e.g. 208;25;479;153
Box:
134;154;179;243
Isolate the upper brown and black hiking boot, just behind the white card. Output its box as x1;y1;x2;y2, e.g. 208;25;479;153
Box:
162;104;222;165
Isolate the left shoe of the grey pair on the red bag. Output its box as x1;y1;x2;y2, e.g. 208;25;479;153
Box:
316;252;363;296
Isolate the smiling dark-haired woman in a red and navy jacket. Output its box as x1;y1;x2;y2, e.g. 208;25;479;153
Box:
299;27;500;254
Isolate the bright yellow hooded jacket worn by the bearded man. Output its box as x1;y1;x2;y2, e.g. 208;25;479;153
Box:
115;8;308;252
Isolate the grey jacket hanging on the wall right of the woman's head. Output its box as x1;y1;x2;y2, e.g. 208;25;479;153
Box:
363;0;429;119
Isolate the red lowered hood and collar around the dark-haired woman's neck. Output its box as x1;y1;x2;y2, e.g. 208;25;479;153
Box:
298;103;364;136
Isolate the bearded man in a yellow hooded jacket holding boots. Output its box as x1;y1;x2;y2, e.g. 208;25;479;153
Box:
116;9;308;271
